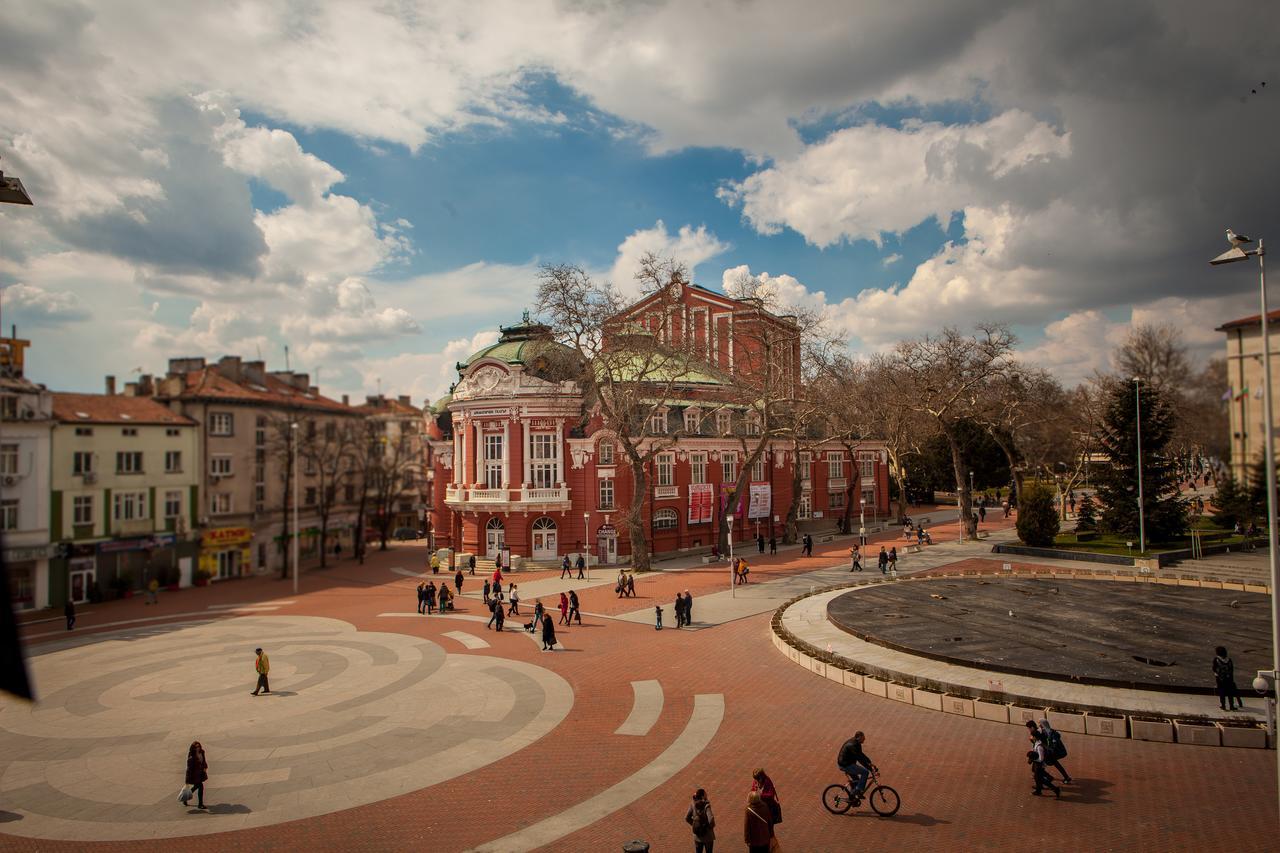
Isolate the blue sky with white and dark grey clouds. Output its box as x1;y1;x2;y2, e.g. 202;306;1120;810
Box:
0;0;1280;403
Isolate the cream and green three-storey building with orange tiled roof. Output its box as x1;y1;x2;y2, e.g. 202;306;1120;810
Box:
46;387;198;606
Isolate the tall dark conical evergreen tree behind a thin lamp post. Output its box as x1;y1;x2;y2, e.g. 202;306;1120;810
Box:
1096;383;1187;542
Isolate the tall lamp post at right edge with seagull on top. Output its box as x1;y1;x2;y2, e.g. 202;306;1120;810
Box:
1210;228;1280;779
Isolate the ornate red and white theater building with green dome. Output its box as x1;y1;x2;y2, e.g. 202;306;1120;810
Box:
426;284;888;565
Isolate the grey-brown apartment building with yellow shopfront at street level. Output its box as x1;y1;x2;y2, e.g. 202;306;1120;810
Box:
133;356;361;579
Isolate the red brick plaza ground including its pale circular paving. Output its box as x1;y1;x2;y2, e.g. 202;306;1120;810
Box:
0;525;1277;850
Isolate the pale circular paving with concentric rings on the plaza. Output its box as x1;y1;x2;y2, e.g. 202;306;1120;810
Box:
0;616;573;840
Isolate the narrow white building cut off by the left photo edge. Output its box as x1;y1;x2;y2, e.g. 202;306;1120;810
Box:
0;337;56;610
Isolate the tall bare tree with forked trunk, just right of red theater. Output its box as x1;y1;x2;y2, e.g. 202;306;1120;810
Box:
893;324;1016;537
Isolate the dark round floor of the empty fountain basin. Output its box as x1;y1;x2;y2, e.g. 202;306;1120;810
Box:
827;576;1271;693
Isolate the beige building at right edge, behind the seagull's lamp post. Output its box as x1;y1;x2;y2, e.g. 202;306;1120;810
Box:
1217;311;1280;483
